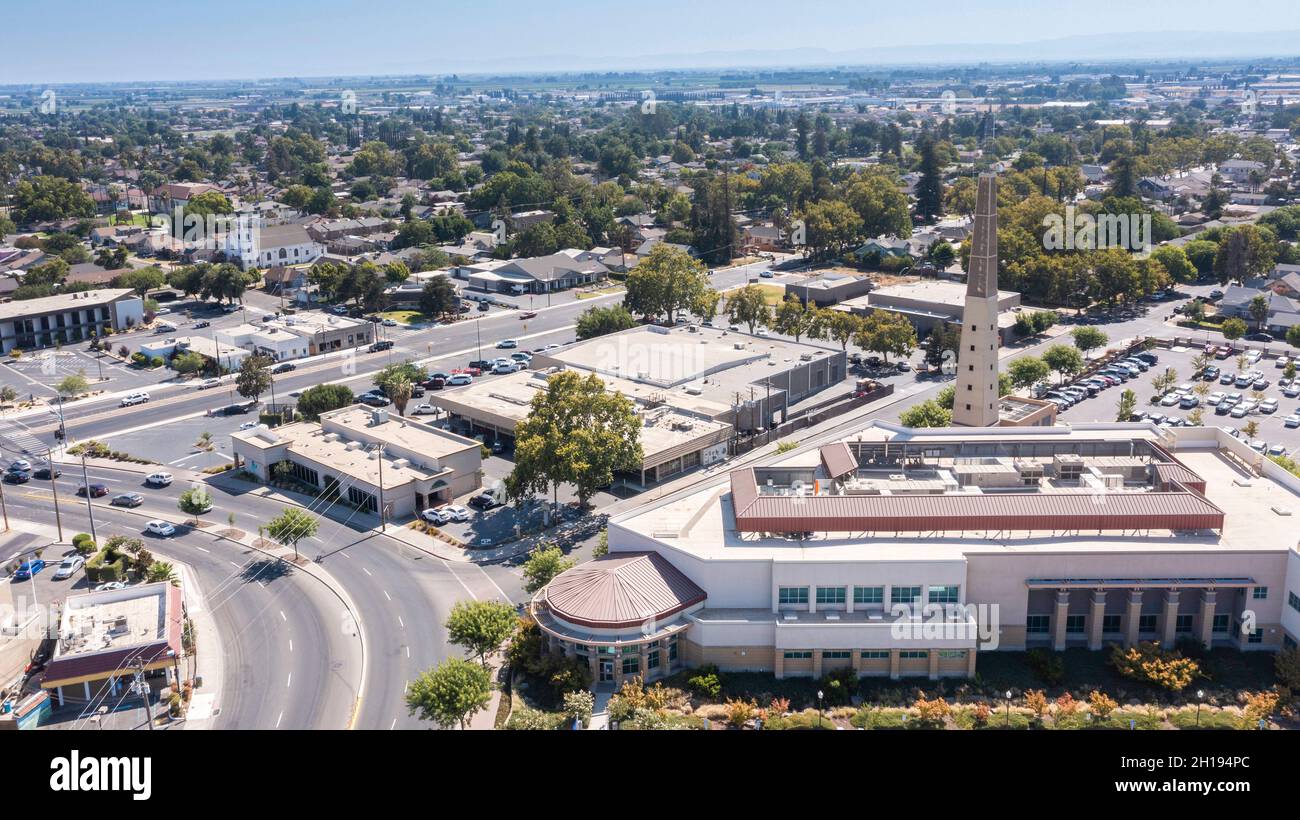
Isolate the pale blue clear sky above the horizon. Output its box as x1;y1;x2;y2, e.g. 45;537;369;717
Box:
0;0;1300;86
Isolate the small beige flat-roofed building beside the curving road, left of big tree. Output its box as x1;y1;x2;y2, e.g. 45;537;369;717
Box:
231;404;482;520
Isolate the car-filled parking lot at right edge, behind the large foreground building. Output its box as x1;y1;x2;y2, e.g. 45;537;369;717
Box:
1058;347;1300;456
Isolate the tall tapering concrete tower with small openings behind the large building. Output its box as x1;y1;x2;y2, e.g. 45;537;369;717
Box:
953;174;1001;428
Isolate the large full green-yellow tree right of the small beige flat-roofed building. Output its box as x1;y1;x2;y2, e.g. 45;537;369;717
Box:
506;371;644;506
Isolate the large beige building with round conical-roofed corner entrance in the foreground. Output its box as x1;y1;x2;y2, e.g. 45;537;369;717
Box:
533;421;1300;685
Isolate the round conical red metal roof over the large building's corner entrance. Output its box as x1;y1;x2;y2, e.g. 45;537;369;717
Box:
543;552;705;629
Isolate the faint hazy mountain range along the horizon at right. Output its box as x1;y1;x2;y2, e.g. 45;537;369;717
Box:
412;30;1300;74
